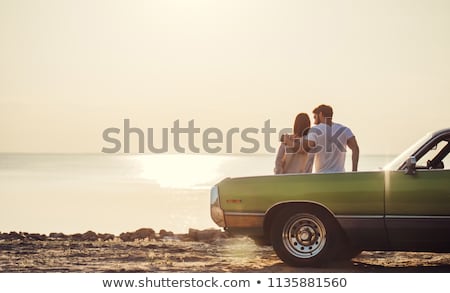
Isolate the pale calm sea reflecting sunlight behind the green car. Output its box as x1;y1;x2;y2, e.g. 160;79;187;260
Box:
0;154;393;235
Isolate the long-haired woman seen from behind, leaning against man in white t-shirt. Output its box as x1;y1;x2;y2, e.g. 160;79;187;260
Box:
274;113;314;174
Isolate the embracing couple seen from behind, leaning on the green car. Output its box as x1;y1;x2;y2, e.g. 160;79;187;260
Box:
274;105;359;174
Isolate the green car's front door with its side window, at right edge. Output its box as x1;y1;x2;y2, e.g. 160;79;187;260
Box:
385;137;450;251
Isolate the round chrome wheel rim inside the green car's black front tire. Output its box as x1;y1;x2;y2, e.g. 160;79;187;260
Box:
281;214;327;259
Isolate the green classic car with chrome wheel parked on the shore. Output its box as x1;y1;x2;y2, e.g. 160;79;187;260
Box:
211;128;450;266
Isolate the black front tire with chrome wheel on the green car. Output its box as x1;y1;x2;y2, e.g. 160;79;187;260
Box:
270;206;341;267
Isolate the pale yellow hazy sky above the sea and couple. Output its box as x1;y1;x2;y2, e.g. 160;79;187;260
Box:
0;0;450;154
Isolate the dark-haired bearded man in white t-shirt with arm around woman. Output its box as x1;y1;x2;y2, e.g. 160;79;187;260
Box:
304;105;359;173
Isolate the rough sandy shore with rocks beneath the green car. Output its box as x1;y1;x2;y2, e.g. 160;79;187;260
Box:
0;229;450;273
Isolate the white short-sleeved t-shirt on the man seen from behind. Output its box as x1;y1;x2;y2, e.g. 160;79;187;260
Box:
308;123;354;173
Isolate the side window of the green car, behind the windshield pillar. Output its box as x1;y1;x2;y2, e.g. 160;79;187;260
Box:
416;140;450;170
